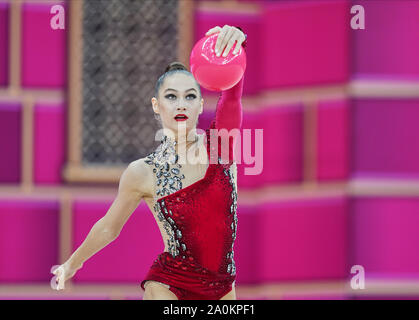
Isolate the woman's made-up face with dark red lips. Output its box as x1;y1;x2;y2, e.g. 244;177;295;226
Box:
151;73;204;134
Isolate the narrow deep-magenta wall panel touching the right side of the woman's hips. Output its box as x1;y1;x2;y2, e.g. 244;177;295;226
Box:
233;203;259;284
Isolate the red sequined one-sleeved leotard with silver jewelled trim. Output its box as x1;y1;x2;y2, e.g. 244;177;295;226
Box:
141;74;244;300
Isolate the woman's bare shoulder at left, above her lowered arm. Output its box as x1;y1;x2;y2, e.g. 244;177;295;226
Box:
120;158;153;197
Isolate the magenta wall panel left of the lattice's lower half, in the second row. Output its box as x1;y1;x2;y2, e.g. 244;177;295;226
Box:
34;104;67;183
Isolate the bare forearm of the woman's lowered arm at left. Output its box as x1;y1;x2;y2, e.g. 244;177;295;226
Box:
68;219;117;269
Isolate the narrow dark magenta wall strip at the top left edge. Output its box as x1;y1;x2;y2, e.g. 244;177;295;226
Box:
0;3;9;86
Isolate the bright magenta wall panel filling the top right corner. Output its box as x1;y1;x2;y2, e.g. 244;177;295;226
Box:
351;0;419;79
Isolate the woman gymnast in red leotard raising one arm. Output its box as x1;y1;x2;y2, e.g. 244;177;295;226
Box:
52;25;246;300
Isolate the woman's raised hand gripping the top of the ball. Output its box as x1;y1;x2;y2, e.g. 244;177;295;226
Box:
205;24;246;57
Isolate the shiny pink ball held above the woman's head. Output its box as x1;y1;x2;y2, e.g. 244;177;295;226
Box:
190;33;246;91
